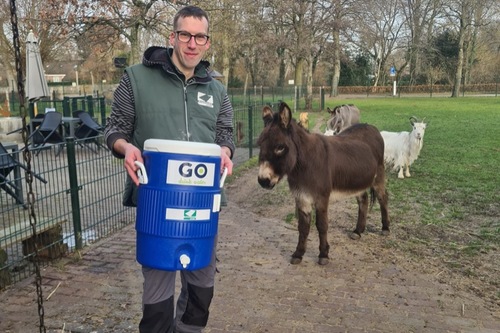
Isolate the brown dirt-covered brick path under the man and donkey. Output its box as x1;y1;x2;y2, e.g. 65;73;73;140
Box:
0;115;500;333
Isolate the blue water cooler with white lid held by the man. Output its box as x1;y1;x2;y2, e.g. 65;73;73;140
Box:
136;139;225;271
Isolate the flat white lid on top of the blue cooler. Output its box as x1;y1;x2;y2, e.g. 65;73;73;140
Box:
144;139;221;156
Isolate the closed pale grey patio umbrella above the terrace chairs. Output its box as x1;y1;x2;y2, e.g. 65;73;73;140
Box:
25;30;50;102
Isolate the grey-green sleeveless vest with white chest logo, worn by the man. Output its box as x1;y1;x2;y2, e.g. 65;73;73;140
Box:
123;64;225;207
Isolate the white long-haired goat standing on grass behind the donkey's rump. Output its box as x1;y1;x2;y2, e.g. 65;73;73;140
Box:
380;117;427;179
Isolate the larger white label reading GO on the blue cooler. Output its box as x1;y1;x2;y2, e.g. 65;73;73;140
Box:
167;160;215;187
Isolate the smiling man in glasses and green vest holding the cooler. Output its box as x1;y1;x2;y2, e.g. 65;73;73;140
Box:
105;6;235;333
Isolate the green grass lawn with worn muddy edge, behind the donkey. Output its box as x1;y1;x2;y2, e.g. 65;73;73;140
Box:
297;97;500;301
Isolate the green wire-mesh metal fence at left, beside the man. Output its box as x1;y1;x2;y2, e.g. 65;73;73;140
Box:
0;138;135;289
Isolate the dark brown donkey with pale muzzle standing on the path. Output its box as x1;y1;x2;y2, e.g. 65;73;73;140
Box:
258;103;389;265
